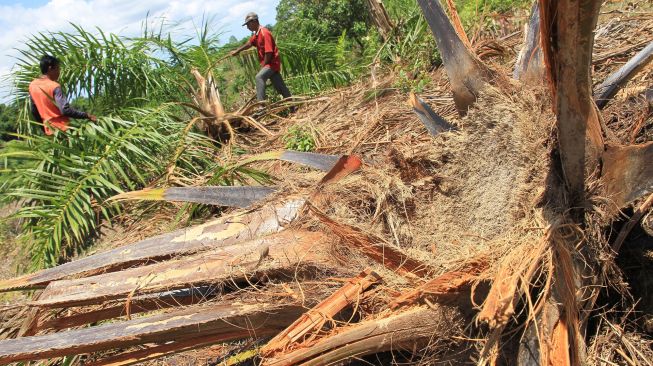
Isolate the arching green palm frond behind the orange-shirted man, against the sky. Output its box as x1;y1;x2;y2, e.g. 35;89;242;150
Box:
14;24;166;108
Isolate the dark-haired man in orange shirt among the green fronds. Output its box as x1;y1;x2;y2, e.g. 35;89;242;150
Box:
29;55;97;135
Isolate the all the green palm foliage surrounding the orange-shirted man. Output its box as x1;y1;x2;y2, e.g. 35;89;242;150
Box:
0;23;236;268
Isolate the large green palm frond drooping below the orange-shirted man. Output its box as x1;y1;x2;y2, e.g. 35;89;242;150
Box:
0;108;219;268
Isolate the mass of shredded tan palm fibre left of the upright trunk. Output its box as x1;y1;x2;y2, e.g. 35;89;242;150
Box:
268;86;551;274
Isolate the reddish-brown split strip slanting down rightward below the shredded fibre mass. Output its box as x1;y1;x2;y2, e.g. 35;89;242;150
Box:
308;205;432;277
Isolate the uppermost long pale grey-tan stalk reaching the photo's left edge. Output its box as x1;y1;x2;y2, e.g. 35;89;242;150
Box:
0;199;304;291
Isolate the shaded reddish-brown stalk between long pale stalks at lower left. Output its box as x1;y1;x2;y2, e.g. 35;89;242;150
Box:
35;286;217;331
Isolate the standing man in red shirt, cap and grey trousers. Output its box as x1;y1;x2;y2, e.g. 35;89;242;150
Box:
231;13;290;101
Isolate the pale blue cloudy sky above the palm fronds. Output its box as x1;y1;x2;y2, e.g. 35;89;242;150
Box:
0;0;279;102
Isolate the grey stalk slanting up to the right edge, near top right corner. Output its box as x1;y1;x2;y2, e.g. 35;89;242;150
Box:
594;42;653;108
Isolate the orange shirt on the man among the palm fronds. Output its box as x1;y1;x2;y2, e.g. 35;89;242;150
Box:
29;77;69;135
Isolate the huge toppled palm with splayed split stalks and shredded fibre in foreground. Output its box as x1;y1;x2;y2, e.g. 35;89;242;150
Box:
0;0;653;365
